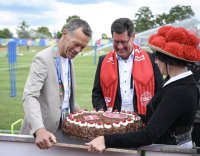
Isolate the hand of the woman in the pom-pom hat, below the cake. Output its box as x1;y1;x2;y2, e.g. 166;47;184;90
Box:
85;136;106;153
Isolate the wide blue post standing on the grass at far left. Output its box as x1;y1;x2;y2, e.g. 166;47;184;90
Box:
8;41;16;97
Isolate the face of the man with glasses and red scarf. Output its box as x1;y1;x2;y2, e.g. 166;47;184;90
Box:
113;31;134;60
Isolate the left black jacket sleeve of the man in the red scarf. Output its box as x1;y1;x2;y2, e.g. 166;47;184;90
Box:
92;55;106;110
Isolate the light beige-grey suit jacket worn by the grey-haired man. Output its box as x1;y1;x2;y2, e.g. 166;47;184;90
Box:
20;47;75;135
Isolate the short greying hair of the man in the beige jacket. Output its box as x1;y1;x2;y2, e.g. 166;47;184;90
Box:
64;18;92;37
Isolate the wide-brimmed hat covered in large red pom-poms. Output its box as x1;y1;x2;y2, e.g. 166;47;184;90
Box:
148;26;200;62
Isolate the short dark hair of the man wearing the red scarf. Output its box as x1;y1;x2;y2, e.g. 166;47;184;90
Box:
111;18;134;37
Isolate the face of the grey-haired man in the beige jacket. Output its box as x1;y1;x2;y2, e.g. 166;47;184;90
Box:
58;27;90;59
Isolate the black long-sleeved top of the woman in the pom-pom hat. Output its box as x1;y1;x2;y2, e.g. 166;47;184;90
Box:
104;75;199;148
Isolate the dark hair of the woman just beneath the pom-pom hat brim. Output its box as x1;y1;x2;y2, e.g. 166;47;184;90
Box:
155;51;188;67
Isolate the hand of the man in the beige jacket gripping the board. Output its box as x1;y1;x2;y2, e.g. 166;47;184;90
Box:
35;128;57;149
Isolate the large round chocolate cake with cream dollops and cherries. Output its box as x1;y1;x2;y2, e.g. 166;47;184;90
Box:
62;110;142;140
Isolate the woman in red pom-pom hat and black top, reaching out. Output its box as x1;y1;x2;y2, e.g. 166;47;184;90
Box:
86;26;200;152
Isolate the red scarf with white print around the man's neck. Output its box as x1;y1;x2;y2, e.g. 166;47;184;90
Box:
100;44;155;114
